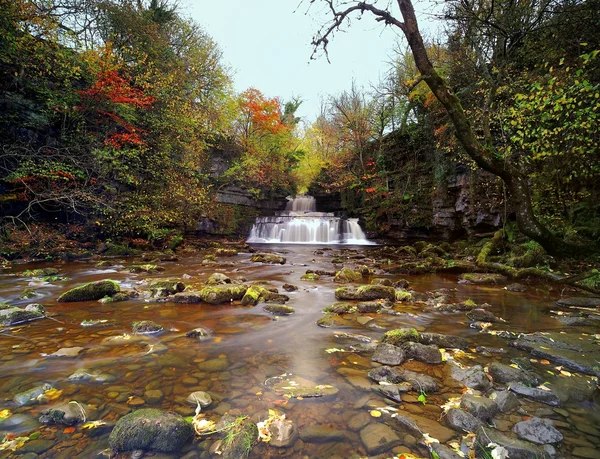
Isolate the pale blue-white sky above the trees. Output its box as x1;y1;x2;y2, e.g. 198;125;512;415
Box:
181;0;442;122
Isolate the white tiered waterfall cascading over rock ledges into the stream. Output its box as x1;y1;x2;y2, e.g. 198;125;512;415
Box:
248;195;373;245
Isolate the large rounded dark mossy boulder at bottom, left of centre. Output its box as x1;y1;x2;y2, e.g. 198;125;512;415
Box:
108;408;194;453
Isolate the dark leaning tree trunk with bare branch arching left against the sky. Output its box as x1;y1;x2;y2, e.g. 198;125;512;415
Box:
311;0;592;255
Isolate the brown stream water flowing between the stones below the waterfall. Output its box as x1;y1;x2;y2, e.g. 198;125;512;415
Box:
0;245;600;458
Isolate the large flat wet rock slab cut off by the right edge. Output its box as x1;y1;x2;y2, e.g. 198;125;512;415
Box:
510;332;600;377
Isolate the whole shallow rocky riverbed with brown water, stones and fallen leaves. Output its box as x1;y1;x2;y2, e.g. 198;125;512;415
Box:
0;245;600;459
